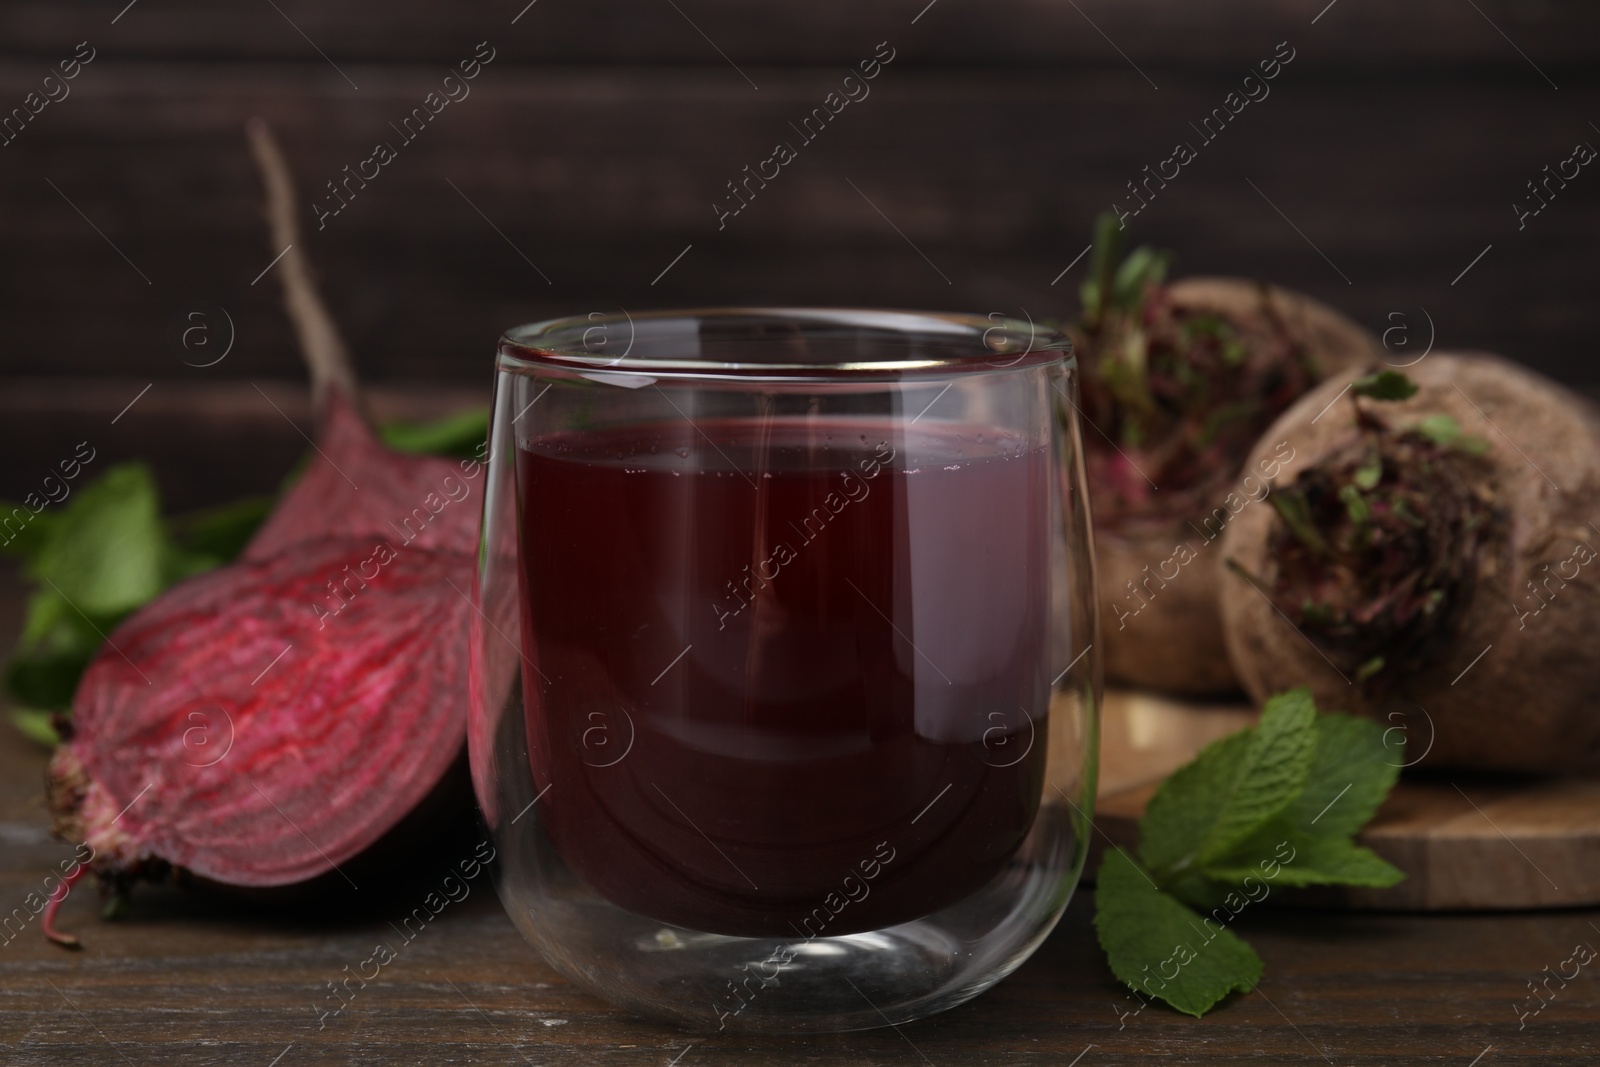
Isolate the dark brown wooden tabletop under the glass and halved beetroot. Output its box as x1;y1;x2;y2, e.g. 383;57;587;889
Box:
0;569;1600;1067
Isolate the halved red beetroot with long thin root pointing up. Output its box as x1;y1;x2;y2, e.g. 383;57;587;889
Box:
42;122;482;944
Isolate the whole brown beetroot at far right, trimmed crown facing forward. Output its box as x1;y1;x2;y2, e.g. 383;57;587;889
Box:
1221;354;1600;771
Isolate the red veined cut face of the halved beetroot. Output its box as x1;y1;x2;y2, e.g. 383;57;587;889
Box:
53;537;472;886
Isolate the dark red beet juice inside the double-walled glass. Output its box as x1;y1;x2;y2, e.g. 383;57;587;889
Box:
518;418;1051;936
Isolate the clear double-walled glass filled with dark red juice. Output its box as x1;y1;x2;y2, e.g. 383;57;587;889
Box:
470;309;1099;1032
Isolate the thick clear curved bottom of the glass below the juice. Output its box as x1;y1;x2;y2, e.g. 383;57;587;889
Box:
496;806;1082;1033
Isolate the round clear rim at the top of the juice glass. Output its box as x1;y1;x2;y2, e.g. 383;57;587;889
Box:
499;306;1075;381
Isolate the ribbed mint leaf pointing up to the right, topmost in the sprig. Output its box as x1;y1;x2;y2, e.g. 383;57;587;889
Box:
1139;688;1317;881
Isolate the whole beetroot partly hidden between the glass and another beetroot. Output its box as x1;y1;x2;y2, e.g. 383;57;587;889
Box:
1074;219;1382;694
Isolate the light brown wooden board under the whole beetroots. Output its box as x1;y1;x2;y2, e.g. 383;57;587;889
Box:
1090;689;1600;910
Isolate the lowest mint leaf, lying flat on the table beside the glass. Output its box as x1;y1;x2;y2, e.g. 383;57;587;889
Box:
1094;849;1262;1019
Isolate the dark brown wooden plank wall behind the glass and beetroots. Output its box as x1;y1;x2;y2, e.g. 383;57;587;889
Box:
0;0;1600;494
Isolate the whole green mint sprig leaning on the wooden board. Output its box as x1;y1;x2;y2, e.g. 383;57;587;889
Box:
1094;689;1405;1017
